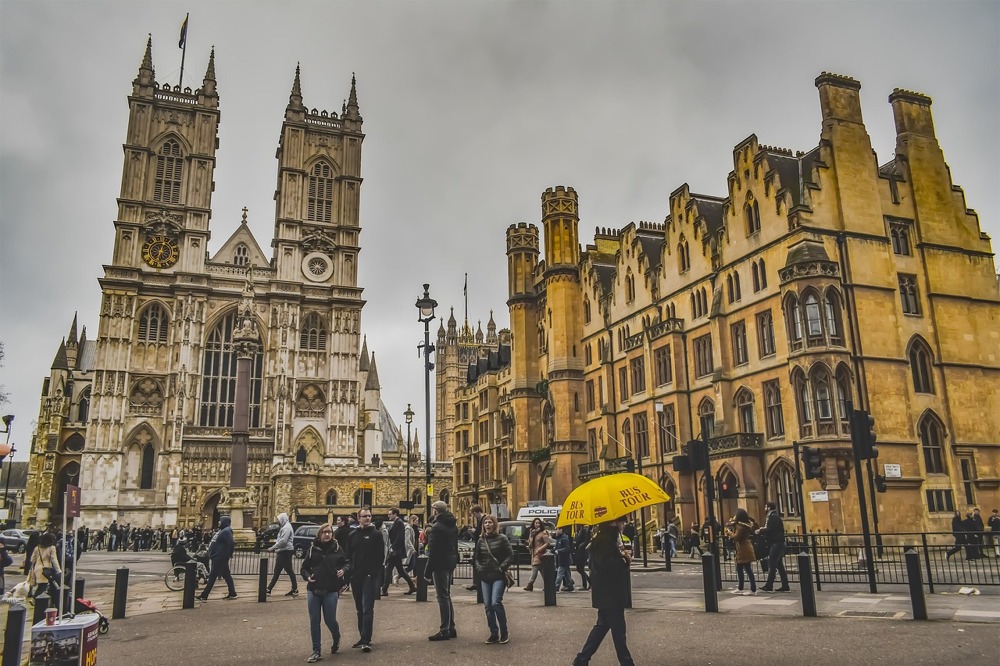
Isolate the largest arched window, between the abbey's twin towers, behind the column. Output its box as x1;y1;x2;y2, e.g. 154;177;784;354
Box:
200;311;263;428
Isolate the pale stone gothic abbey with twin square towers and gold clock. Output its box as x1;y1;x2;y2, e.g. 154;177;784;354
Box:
24;39;450;527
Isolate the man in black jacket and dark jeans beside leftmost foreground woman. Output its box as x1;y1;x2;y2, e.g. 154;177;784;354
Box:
346;507;385;652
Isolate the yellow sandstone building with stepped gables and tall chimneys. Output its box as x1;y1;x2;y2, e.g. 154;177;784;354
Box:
437;73;1000;533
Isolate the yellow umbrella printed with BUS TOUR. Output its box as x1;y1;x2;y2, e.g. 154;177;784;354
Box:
556;472;670;527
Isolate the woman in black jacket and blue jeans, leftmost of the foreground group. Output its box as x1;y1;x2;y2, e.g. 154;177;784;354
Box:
302;523;347;663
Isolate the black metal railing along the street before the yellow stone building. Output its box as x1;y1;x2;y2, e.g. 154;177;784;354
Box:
721;532;1000;593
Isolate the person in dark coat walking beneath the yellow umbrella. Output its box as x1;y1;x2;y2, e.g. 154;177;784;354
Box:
573;518;634;666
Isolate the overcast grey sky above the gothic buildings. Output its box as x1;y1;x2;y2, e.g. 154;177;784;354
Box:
0;0;1000;460
